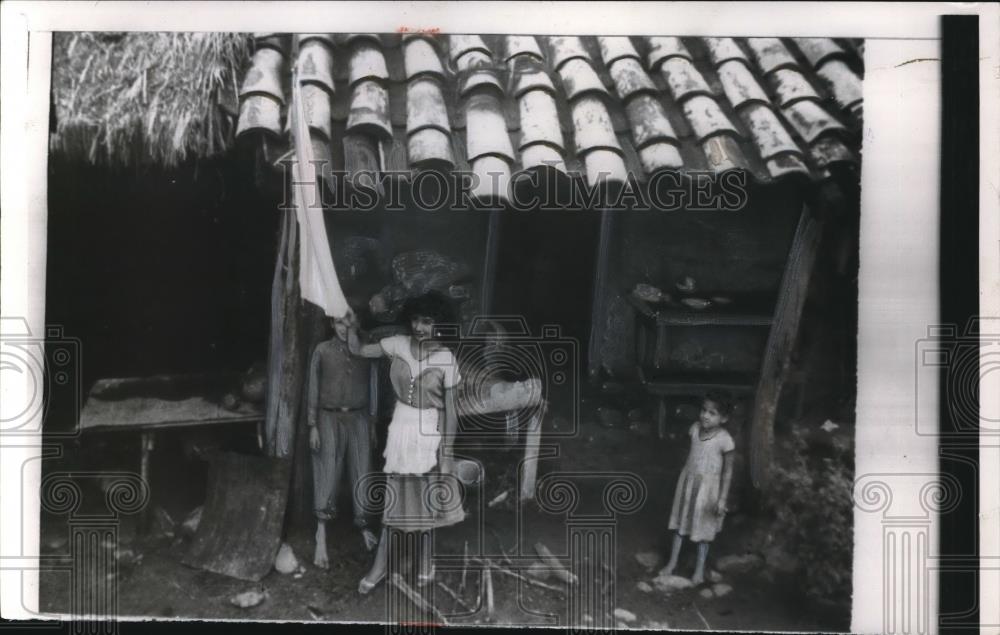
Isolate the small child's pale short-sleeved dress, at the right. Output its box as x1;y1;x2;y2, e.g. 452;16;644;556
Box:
670;423;736;542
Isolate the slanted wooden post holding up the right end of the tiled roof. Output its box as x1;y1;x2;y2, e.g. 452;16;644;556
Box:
750;206;823;489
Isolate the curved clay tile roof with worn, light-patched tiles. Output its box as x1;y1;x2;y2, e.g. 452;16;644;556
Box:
237;33;862;201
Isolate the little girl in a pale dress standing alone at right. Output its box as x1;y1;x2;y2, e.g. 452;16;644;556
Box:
667;394;736;584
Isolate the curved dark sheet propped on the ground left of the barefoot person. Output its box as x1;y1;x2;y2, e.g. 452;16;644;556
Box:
181;452;291;581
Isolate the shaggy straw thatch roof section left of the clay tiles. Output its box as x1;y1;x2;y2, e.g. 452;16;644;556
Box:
51;33;250;167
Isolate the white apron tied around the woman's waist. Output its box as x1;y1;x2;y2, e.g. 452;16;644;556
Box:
382;401;441;474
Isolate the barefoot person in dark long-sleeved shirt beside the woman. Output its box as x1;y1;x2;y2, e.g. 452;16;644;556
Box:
308;320;377;569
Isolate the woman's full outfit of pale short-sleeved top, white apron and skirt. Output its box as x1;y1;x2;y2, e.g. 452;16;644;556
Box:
379;335;465;531
